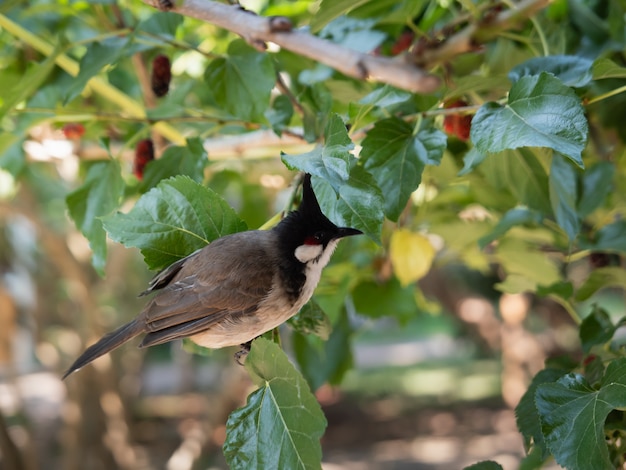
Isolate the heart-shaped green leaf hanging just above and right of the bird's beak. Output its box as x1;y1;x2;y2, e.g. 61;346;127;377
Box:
361;117;447;221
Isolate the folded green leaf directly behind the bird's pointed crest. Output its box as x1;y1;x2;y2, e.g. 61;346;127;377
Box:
282;114;384;242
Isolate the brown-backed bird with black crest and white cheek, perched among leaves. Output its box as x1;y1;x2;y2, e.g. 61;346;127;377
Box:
63;174;363;379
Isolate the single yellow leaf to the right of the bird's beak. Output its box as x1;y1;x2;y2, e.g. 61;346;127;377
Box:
389;229;436;287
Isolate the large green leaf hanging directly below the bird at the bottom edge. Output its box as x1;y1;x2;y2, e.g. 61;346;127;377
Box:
223;338;327;470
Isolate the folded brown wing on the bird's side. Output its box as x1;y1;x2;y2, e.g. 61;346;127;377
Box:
141;232;275;346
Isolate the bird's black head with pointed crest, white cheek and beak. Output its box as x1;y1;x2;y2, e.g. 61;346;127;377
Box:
276;174;363;267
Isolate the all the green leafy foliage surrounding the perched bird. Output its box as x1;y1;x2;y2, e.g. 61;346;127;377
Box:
0;0;626;469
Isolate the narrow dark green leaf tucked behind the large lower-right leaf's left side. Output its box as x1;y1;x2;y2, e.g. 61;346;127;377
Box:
515;368;569;459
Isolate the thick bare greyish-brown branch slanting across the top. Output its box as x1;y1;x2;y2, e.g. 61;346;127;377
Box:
143;0;440;93
